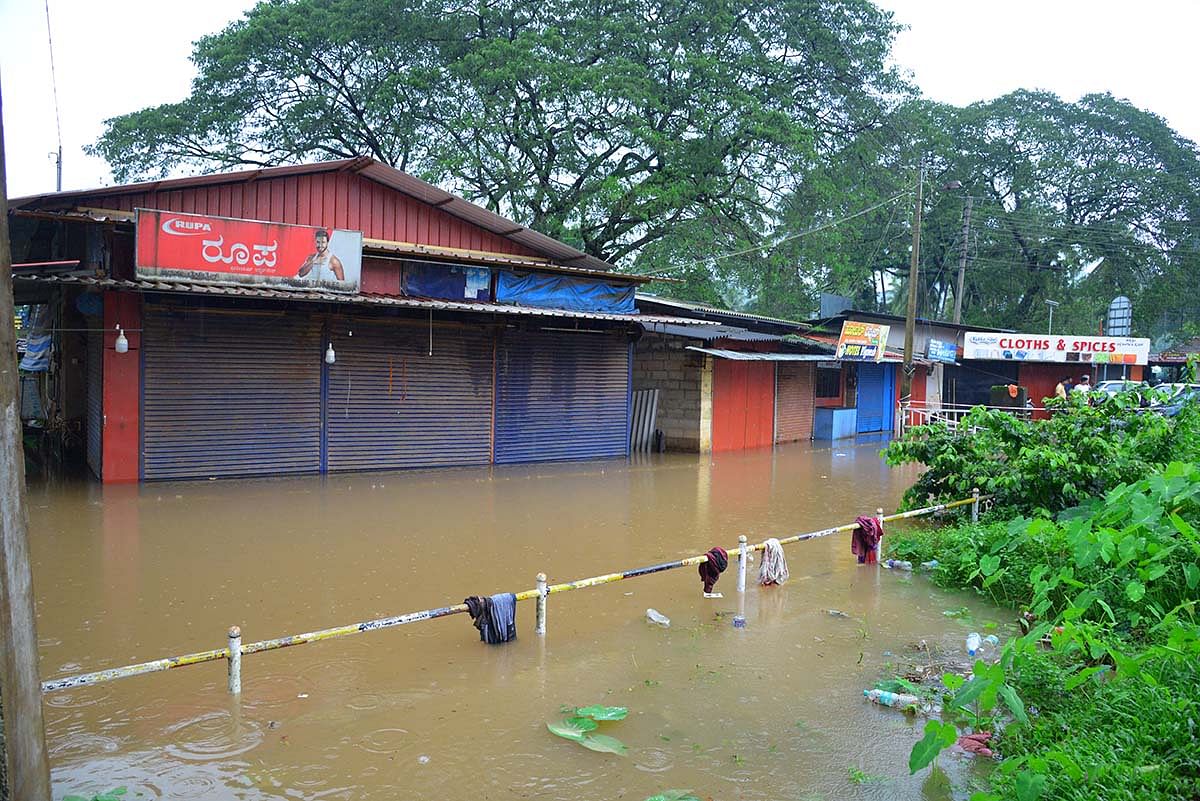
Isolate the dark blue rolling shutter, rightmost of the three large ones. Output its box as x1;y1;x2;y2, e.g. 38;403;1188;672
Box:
496;331;631;464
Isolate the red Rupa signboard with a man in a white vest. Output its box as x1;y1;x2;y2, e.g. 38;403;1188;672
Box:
137;209;362;293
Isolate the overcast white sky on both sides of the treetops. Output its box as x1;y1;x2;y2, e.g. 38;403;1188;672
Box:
0;0;1200;197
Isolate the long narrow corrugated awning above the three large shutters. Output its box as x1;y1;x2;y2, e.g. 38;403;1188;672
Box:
13;276;715;325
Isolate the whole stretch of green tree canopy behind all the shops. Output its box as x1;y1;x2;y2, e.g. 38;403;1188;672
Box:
92;0;1200;336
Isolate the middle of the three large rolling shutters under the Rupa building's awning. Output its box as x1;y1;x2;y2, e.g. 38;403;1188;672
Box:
325;324;494;471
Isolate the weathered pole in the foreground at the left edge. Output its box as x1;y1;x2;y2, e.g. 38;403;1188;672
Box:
0;76;50;801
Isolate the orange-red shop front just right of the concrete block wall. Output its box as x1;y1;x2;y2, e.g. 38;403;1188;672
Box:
713;359;775;451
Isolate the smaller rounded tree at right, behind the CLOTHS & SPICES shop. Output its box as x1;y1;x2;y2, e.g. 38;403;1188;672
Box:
692;91;1200;336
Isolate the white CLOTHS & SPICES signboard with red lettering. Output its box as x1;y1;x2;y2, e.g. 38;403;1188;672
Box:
962;331;1150;365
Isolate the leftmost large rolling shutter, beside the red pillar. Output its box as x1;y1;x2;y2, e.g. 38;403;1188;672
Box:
142;306;323;480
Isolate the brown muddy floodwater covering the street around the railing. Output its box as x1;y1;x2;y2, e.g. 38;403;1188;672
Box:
29;442;1010;801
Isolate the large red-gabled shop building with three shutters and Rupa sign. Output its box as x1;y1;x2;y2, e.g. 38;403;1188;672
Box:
11;158;703;482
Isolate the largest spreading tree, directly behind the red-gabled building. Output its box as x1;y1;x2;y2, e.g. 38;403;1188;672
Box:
94;0;907;261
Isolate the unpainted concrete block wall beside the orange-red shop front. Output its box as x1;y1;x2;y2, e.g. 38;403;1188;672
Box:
634;332;713;453
